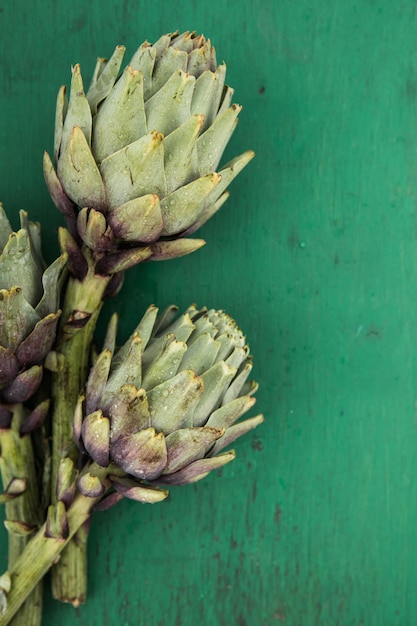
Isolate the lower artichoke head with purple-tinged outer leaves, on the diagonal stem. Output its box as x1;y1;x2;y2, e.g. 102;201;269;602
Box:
74;306;263;502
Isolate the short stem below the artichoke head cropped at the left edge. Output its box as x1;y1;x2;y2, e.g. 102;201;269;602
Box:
0;404;43;626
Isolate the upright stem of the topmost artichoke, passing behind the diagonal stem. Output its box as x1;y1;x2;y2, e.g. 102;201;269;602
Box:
52;256;110;606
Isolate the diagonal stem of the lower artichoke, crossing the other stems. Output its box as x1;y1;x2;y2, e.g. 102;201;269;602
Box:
0;470;108;626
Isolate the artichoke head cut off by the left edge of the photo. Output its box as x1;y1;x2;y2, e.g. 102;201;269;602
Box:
0;204;65;426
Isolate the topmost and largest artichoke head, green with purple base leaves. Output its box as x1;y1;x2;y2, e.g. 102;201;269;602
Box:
44;32;253;273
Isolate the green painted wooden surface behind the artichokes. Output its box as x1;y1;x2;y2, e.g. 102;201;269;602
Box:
0;0;417;626
